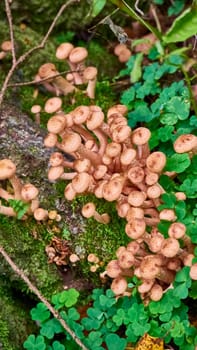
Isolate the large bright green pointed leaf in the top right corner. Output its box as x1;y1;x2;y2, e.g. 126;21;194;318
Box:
163;4;197;43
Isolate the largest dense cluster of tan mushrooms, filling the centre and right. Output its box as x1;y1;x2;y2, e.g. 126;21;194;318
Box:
43;105;197;301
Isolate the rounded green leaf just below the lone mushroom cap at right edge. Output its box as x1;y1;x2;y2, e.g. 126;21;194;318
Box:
165;153;191;173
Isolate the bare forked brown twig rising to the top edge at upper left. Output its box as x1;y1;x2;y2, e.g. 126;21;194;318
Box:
0;0;80;106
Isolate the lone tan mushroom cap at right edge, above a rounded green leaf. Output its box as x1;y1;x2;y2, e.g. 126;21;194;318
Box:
174;134;197;153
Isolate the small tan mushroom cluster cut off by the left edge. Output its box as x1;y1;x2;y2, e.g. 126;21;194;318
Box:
0;159;53;221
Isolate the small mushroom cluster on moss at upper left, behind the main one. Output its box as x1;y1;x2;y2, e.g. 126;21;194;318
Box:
35;43;97;99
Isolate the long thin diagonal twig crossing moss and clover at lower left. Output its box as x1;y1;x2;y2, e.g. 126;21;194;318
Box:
0;246;88;350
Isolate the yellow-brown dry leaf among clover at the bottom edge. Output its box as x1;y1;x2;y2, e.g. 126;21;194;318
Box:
135;333;164;350
